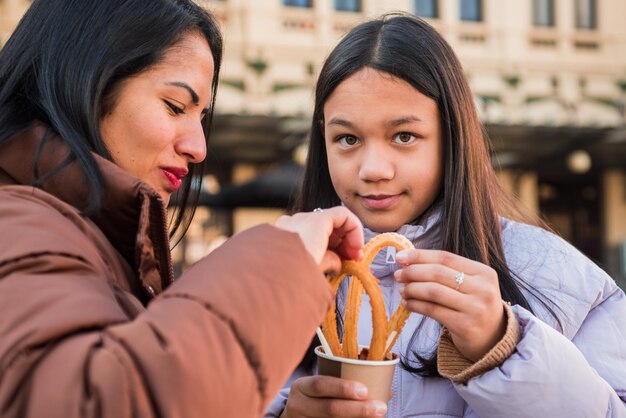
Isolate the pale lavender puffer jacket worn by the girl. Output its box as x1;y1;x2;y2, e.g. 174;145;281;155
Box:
265;214;626;418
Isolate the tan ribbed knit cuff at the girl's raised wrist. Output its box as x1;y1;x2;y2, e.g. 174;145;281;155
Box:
437;302;521;383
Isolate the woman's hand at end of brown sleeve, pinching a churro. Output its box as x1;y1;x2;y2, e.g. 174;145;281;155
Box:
275;206;363;273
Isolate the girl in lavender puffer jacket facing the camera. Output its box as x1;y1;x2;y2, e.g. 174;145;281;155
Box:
268;15;626;418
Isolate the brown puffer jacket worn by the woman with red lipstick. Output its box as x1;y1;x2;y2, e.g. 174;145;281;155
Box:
0;126;332;418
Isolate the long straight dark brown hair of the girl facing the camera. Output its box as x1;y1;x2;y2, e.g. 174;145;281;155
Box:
294;13;552;376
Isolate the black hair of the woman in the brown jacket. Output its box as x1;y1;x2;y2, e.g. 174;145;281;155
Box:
0;0;222;242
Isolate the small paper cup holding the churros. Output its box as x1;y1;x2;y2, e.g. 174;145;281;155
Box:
315;346;400;402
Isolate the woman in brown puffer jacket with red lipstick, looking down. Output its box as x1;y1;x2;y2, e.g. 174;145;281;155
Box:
0;0;363;418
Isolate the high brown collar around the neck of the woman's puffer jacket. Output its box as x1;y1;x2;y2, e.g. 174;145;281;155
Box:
0;124;173;296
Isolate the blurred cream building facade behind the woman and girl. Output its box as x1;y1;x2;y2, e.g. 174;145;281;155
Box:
0;0;626;286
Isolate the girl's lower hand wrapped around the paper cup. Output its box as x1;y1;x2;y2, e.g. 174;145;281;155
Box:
281;376;387;418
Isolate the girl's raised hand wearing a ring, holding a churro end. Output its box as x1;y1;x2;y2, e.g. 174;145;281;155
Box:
395;249;506;362
